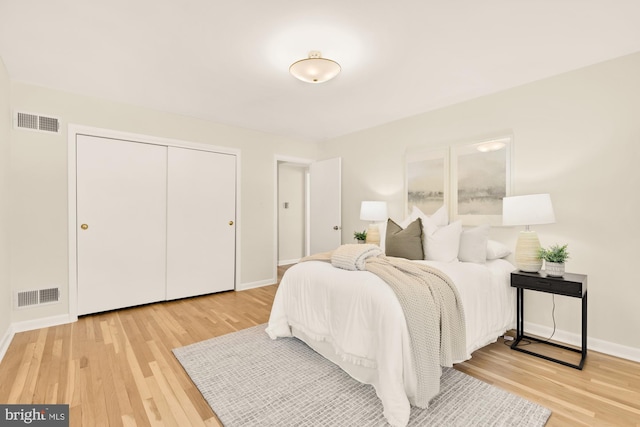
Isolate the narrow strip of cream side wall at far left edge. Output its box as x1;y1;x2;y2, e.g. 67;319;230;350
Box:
0;58;12;352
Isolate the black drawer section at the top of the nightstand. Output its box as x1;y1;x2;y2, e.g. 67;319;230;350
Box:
511;271;587;298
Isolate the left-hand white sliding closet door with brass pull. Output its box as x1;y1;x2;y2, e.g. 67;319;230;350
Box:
76;135;167;314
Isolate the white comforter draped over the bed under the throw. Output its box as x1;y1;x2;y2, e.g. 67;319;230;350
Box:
267;259;515;426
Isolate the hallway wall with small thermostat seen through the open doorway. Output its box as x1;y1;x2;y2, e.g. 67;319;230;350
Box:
278;163;307;265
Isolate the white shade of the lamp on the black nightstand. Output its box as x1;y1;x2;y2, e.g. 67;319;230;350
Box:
502;194;556;225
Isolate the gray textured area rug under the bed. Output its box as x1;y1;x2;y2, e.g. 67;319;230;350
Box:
173;325;551;427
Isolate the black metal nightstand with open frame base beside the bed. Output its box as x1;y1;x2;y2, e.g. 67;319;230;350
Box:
511;270;587;369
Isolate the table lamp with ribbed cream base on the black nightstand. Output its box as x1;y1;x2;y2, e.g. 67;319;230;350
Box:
502;194;556;273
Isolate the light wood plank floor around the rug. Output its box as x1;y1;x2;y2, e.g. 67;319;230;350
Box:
0;269;640;427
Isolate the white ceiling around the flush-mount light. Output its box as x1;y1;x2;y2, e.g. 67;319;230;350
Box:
0;0;640;141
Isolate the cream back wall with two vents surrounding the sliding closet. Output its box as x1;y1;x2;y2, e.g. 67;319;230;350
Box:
8;82;315;322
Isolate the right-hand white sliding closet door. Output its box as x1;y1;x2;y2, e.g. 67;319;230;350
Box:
167;147;236;299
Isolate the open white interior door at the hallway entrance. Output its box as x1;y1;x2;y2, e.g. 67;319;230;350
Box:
309;157;342;254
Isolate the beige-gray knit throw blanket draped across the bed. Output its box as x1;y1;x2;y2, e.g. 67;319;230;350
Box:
303;244;467;408
